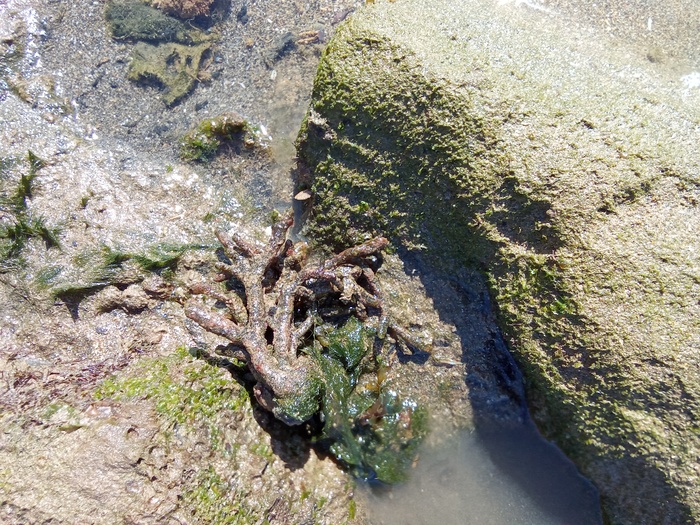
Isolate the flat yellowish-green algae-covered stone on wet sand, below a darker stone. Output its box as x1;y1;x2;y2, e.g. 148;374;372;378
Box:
128;42;211;106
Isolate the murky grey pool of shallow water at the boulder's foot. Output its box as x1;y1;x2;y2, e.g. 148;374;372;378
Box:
367;424;602;525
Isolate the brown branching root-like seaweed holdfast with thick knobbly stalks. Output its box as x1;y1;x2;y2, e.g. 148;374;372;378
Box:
185;211;422;425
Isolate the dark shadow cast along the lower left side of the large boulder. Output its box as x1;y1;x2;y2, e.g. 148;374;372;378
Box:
401;253;602;525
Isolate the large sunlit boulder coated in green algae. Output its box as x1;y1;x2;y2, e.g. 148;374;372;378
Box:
297;0;700;524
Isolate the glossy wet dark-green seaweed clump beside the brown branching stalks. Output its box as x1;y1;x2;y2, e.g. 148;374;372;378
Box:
313;317;428;483
